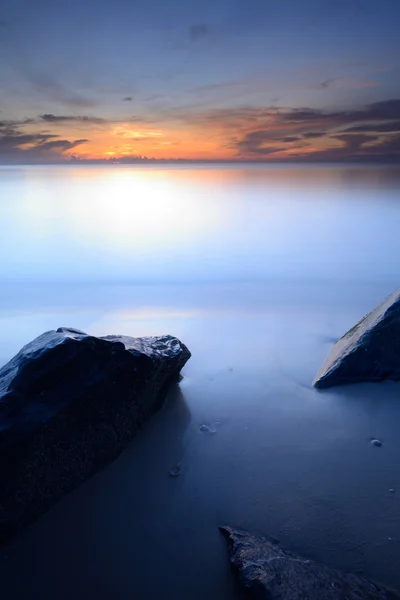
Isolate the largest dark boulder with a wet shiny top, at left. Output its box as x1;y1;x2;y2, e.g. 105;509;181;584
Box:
0;327;190;543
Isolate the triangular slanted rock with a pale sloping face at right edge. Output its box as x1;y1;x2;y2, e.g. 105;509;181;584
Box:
313;290;400;388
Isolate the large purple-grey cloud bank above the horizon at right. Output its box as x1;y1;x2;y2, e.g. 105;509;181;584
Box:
227;99;400;160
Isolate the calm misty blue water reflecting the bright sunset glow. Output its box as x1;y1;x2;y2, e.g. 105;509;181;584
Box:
0;166;400;600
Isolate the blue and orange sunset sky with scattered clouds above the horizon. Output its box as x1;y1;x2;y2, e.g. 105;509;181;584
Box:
0;0;400;164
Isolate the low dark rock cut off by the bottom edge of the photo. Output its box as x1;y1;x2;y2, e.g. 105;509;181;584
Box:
220;527;400;600
